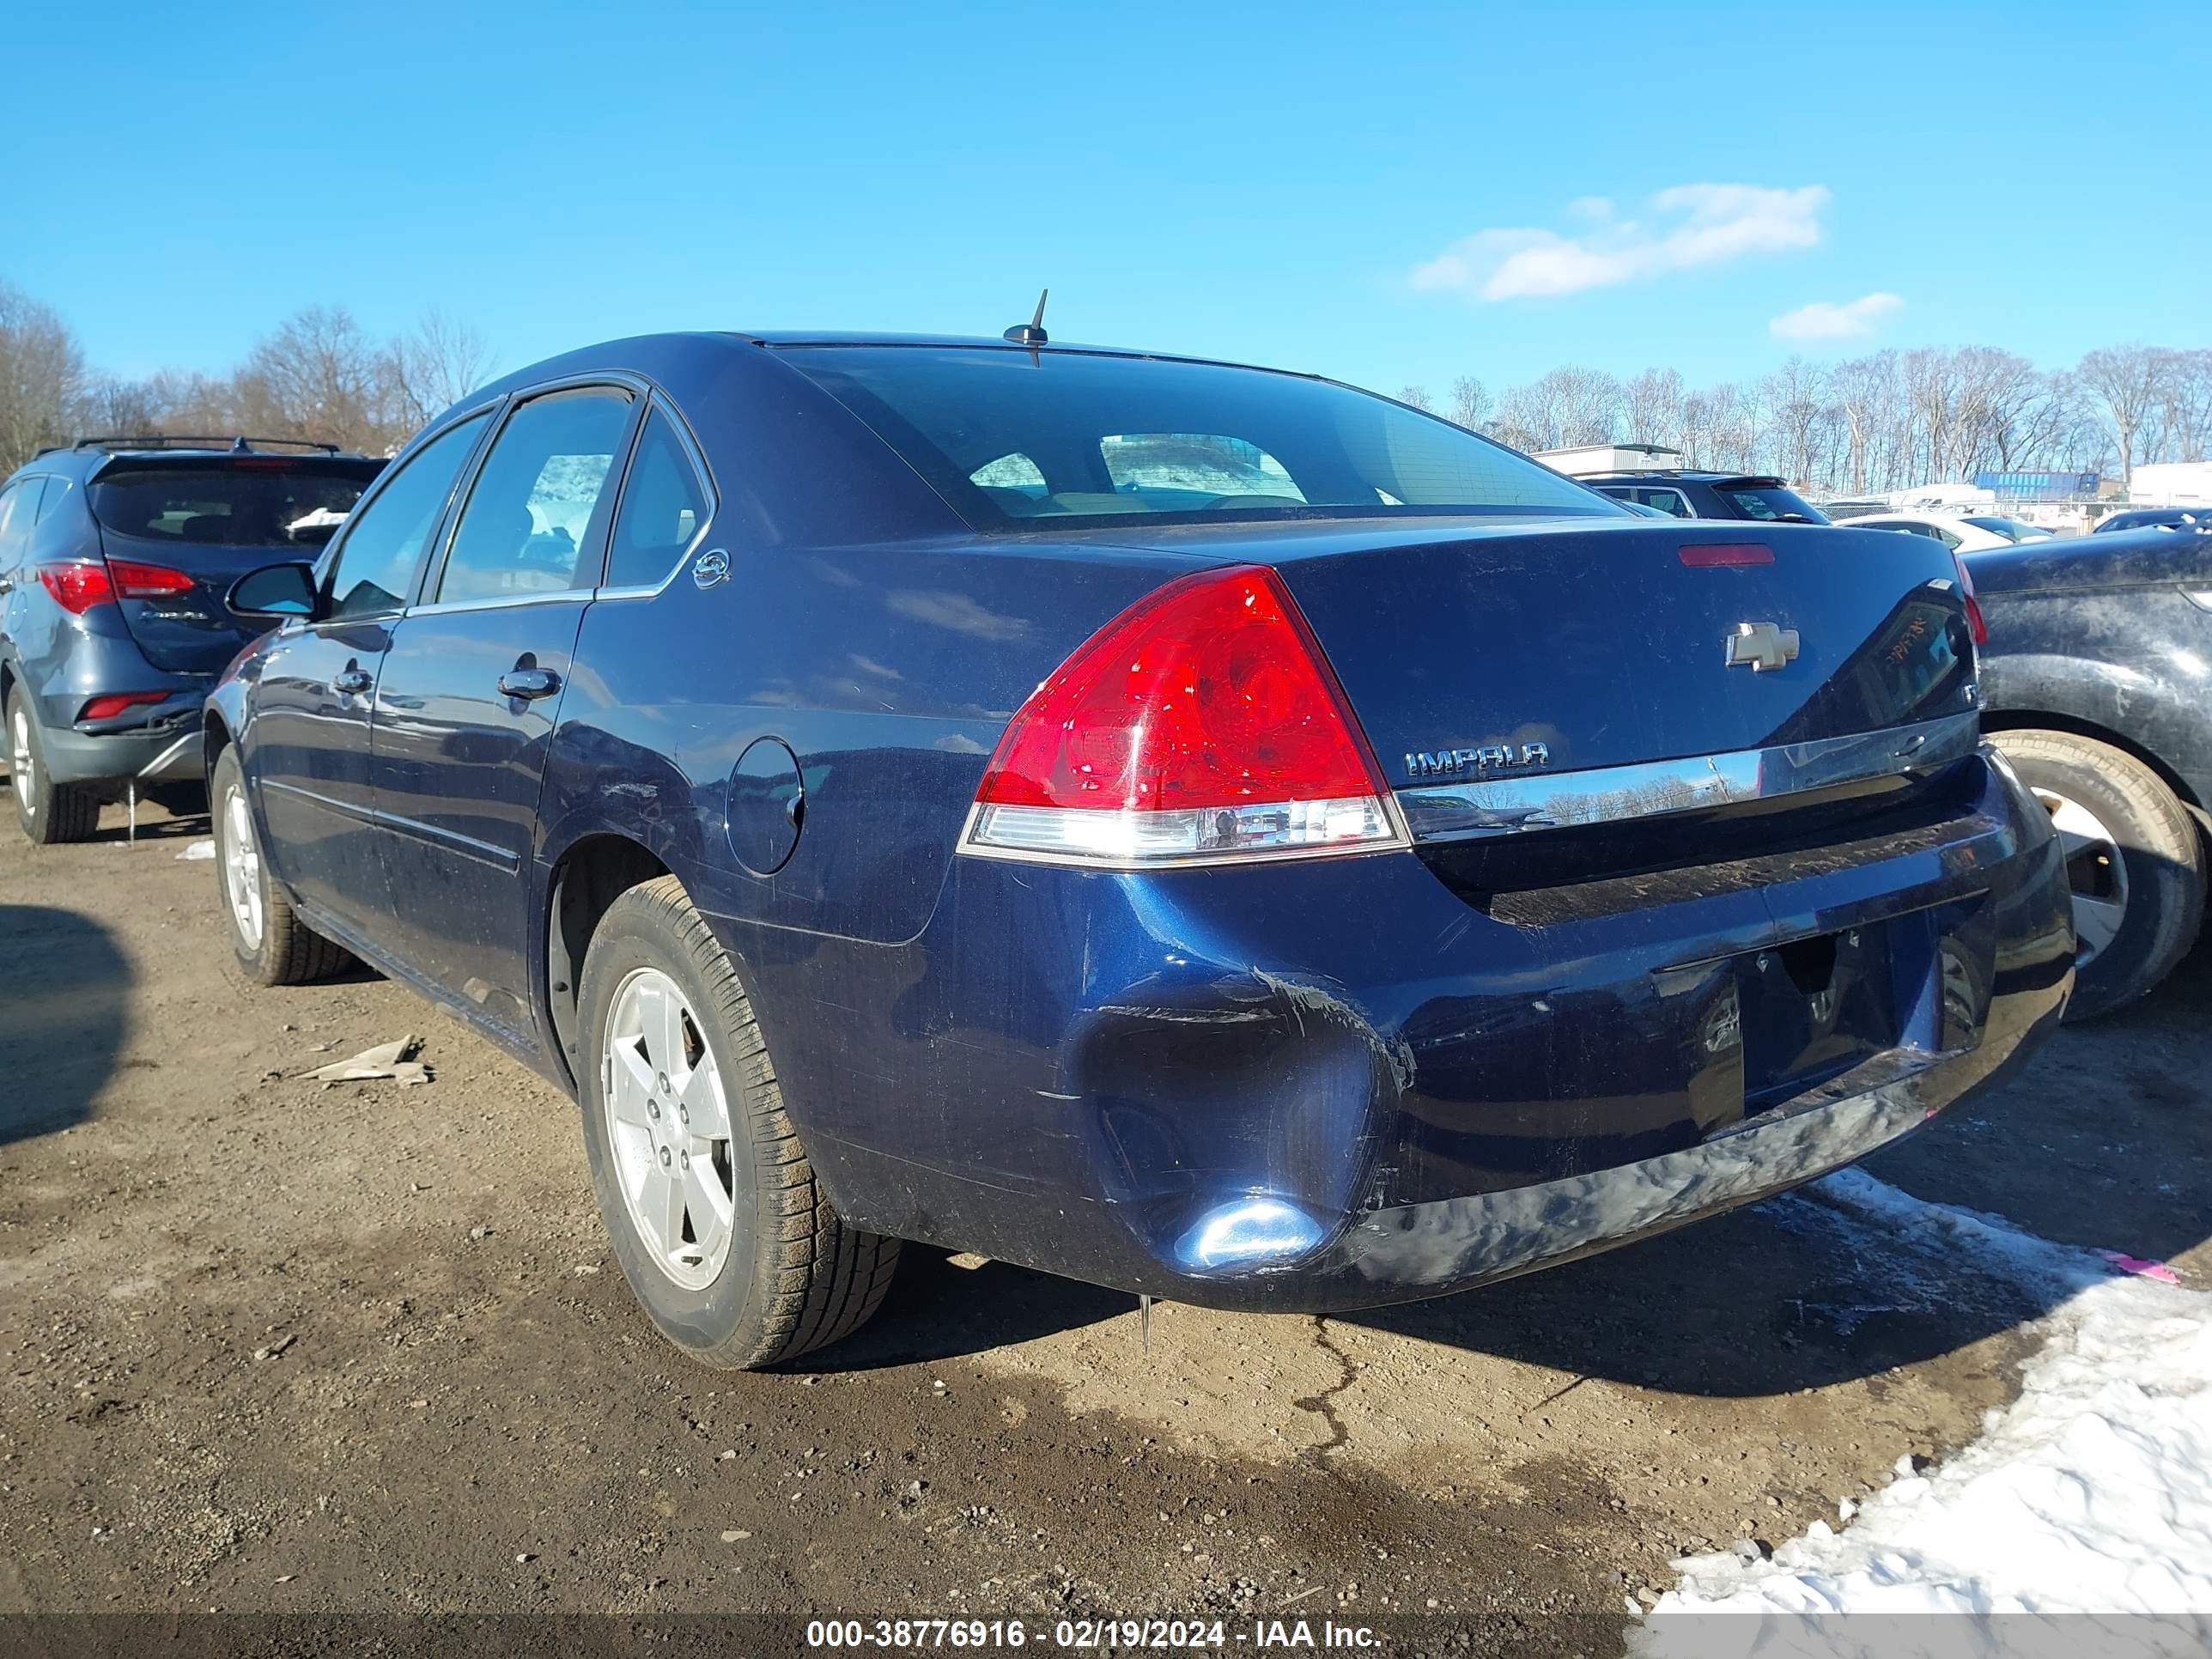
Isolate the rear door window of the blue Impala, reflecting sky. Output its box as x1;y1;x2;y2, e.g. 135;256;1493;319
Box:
435;387;630;604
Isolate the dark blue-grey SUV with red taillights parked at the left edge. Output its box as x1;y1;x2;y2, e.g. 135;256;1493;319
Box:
0;438;383;842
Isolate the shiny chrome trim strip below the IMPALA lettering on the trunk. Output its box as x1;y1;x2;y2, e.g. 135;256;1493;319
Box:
1395;712;1982;845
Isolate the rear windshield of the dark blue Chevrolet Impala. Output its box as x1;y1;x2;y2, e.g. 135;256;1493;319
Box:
783;345;1624;529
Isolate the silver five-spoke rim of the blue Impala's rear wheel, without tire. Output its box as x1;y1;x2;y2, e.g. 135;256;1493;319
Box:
599;967;737;1290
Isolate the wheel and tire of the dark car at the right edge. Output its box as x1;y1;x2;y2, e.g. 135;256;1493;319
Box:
1990;730;2205;1022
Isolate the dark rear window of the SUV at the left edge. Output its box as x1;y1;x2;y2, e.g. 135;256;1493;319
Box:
91;460;376;546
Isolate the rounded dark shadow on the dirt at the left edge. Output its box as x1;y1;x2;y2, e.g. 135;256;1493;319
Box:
0;905;137;1146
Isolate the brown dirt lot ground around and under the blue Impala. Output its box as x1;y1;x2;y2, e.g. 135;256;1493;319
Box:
0;807;2212;1650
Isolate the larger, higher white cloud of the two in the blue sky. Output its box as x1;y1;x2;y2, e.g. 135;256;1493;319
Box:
1411;184;1827;299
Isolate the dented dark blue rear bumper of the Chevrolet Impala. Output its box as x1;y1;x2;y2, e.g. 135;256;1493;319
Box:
717;759;2073;1312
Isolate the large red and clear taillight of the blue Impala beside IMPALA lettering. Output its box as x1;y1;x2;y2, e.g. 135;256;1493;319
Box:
967;566;1401;865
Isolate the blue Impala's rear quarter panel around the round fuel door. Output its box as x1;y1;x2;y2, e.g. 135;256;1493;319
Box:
540;538;1220;942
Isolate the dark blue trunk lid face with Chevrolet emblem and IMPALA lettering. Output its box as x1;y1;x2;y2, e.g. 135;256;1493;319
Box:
1256;522;1975;787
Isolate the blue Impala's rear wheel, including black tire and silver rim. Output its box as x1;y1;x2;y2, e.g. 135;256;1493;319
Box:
577;876;898;1370
